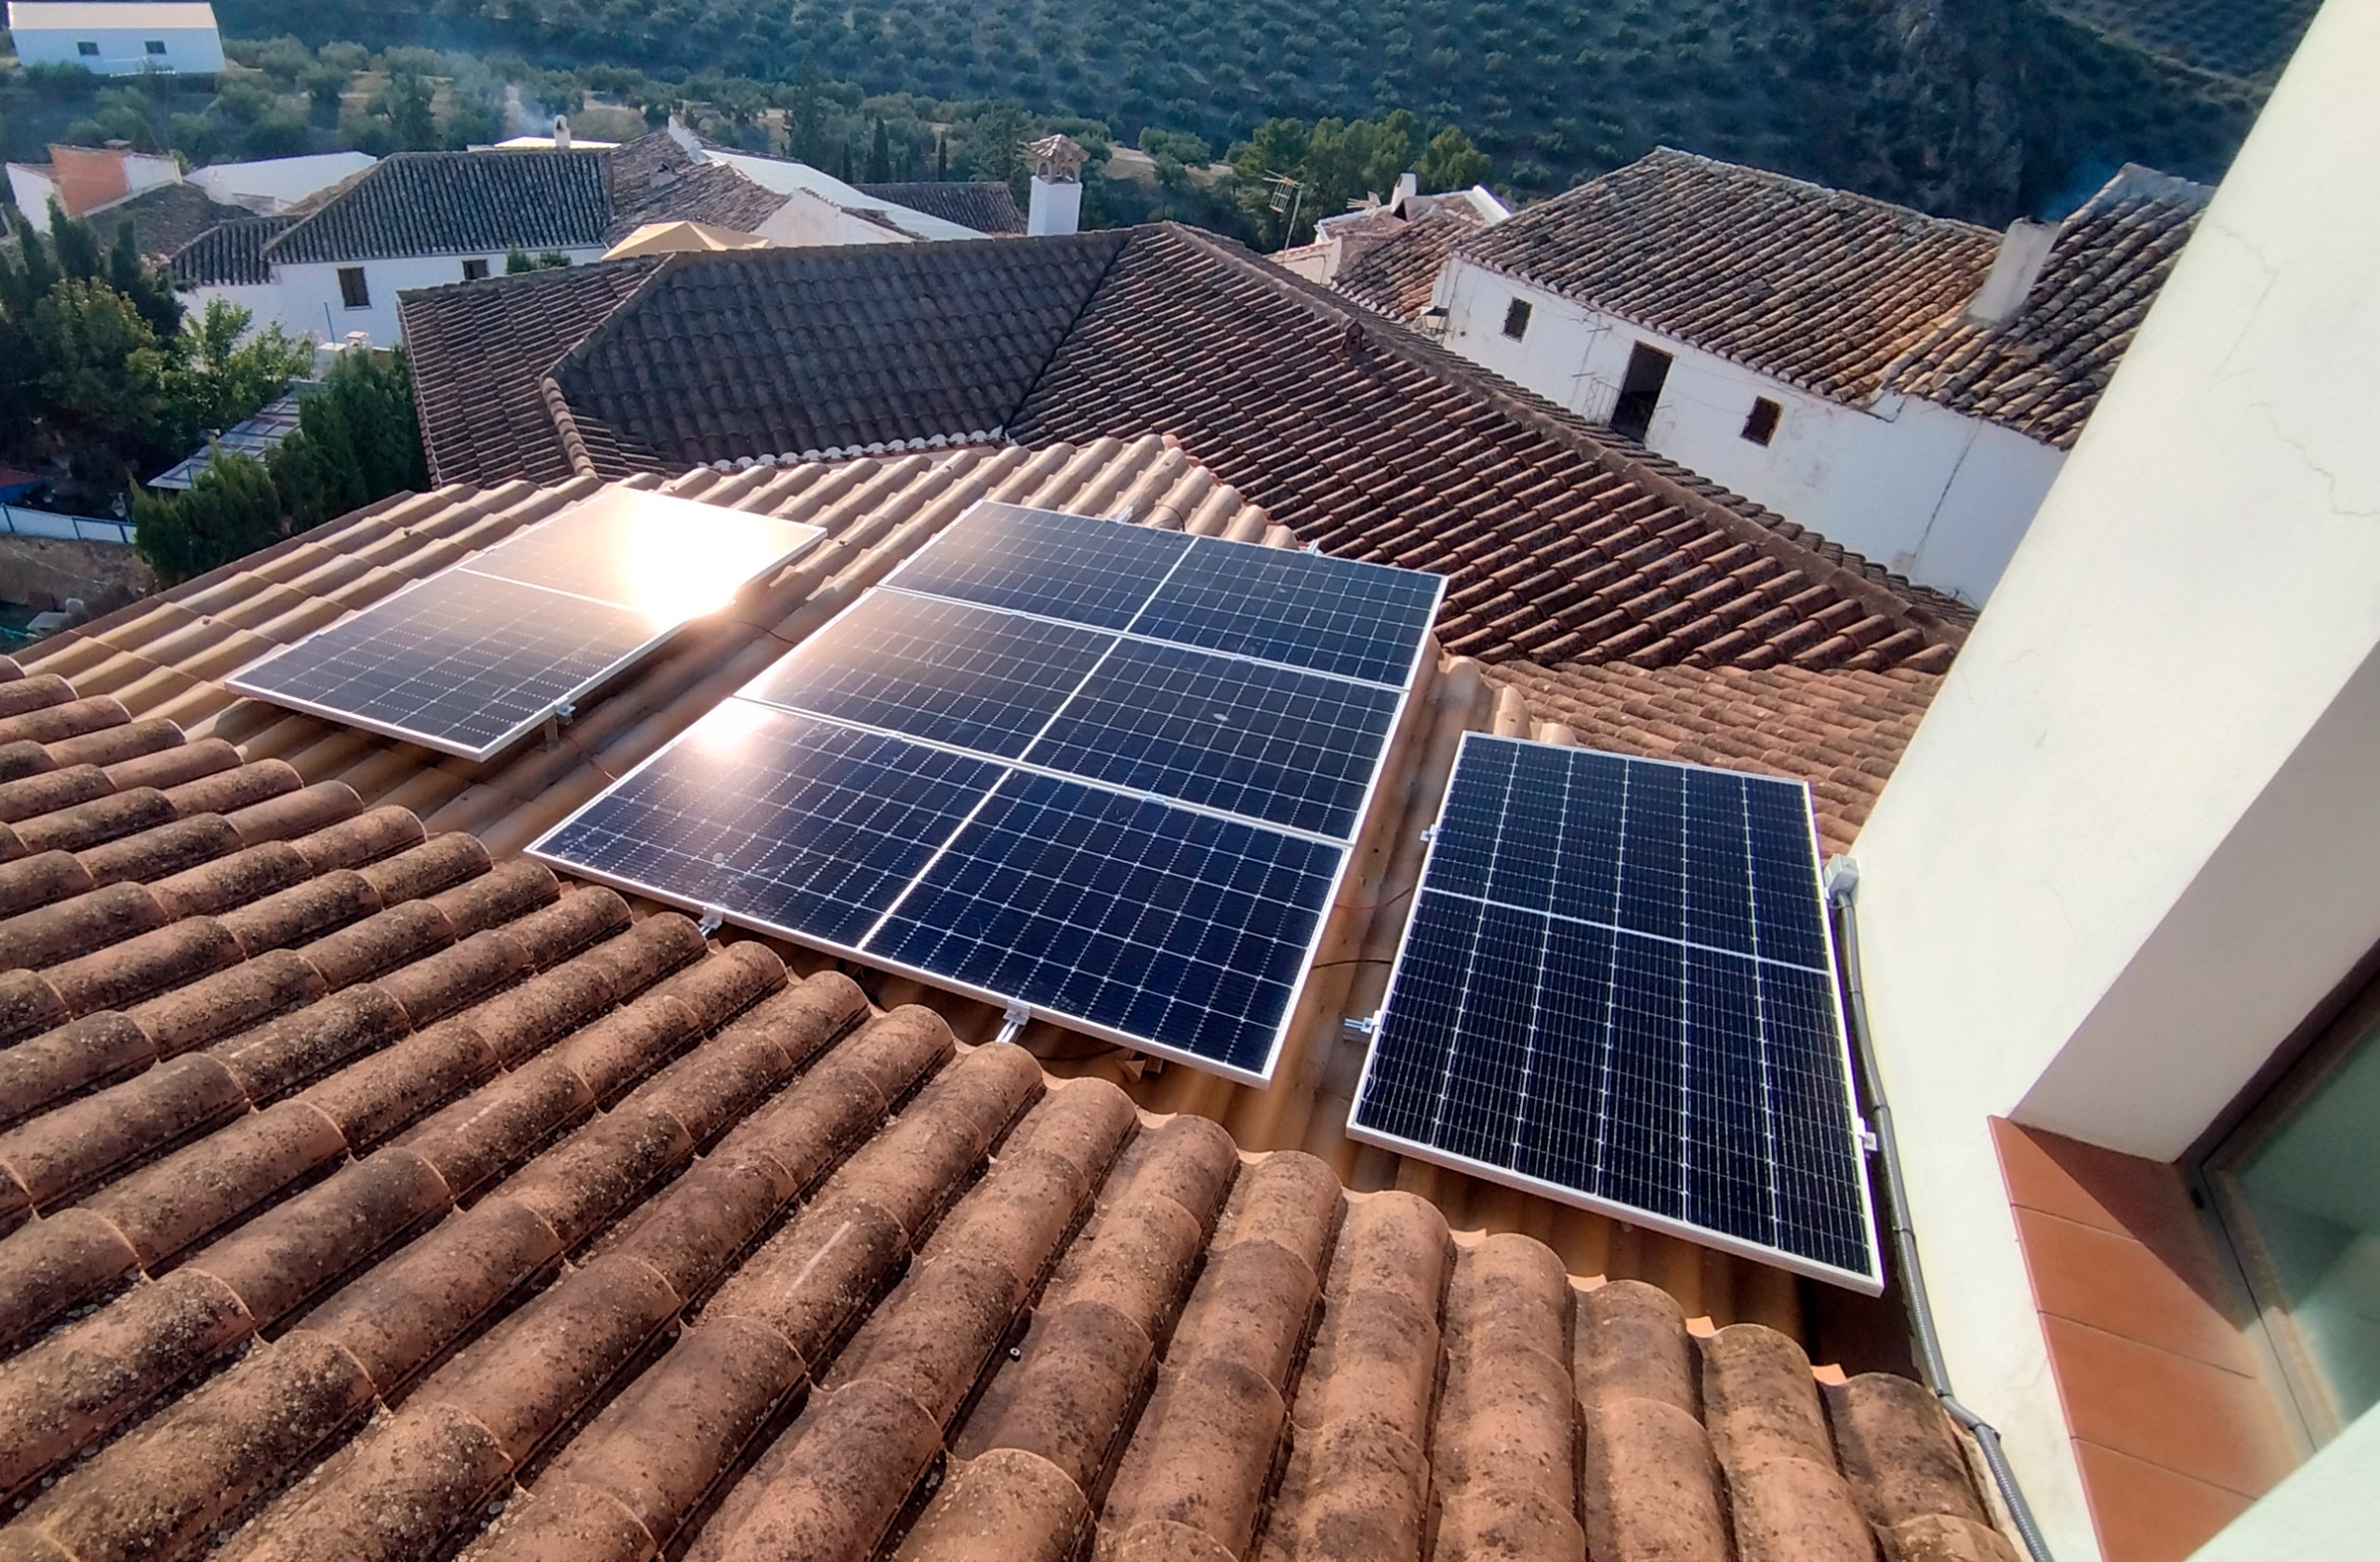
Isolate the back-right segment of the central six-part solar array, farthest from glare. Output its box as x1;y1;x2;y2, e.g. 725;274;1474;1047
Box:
1133;538;1442;688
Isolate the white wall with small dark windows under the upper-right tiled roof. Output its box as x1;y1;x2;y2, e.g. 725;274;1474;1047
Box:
1440;258;2066;602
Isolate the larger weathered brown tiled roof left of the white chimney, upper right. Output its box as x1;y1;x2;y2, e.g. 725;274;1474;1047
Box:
1454;148;1999;403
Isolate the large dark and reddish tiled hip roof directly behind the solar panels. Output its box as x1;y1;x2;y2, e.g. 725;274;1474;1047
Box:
400;224;1971;669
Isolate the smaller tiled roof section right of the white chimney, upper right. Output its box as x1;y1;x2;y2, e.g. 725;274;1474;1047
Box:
1892;165;2214;450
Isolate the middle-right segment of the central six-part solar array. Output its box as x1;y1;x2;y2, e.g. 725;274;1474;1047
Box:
1025;641;1399;838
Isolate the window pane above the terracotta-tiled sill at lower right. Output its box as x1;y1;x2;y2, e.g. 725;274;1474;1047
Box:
2204;984;2380;1443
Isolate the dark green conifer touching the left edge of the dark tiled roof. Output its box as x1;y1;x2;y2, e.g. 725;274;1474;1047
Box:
273;348;430;531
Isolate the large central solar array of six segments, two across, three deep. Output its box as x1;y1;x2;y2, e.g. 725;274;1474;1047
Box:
531;505;1442;1081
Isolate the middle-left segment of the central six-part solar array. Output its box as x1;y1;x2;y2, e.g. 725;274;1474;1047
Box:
743;590;1117;760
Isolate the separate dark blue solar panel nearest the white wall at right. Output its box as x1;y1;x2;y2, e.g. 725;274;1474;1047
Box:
1347;734;1883;1293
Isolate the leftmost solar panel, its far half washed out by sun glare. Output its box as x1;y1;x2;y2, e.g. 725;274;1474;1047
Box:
231;488;824;760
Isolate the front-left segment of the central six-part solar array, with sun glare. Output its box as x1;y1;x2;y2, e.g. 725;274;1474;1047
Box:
531;700;1002;946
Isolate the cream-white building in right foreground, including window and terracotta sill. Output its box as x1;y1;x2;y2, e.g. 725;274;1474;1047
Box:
1854;5;2380;1562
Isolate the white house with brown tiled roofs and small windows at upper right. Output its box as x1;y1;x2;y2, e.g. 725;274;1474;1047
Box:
1408;150;2206;602
